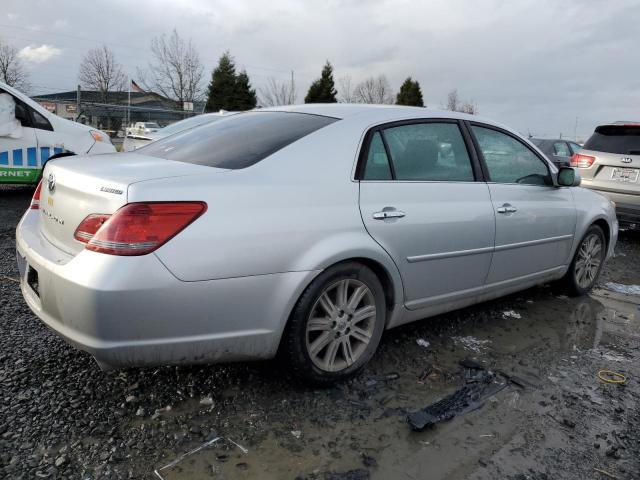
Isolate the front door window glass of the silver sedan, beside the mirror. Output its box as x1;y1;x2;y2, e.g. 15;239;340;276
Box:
471;125;552;185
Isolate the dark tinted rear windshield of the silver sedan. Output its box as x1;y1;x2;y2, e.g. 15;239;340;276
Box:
136;112;337;170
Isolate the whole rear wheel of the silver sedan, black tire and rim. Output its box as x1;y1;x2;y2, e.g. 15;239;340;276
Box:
283;262;386;385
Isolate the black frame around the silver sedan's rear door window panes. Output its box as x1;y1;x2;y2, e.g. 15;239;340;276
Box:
353;117;484;183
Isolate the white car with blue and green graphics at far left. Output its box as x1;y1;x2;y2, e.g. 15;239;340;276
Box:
0;83;116;184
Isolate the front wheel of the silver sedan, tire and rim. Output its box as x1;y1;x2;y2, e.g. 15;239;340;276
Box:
558;225;607;297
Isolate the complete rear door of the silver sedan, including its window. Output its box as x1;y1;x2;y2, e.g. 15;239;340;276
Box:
358;120;495;309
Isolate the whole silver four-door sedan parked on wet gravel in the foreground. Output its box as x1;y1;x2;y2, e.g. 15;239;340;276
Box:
16;104;618;383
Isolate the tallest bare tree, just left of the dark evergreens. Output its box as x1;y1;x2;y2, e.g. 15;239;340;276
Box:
138;29;204;105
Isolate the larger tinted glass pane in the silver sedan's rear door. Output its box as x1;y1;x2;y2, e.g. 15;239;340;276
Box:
374;122;474;182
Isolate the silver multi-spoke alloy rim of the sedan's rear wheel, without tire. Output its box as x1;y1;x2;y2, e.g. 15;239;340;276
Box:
305;278;376;372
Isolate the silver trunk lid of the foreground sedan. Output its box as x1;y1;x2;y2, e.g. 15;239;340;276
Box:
39;154;226;255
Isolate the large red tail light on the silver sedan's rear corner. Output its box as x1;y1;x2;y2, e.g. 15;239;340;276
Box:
78;202;207;255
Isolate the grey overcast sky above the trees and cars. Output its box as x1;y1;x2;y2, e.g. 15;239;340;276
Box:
0;0;640;137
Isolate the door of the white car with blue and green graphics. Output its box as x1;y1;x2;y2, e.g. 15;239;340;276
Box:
0;89;40;183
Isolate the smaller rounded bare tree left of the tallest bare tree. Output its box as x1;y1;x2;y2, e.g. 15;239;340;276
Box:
78;45;127;103
